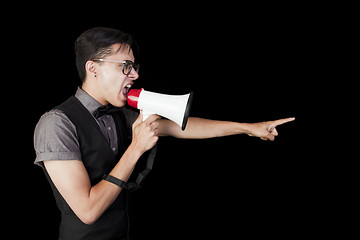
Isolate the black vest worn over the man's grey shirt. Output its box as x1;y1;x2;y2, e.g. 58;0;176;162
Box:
45;97;130;240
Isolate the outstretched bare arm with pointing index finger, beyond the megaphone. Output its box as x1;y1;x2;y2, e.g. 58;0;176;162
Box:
158;117;295;141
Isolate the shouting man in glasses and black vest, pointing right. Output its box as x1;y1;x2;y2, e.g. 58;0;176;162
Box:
34;28;294;240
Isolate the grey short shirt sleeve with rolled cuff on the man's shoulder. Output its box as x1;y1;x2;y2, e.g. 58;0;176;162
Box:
34;110;81;167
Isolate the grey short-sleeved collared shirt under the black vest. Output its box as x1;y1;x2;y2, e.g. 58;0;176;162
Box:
34;88;139;167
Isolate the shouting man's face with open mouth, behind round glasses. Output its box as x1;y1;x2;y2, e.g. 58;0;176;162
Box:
94;44;139;107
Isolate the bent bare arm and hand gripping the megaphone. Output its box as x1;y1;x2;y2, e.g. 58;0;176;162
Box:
44;113;159;224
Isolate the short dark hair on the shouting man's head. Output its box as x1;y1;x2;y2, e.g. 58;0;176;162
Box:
75;27;138;82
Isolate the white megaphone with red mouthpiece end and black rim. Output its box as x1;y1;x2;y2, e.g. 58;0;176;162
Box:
127;88;193;131
